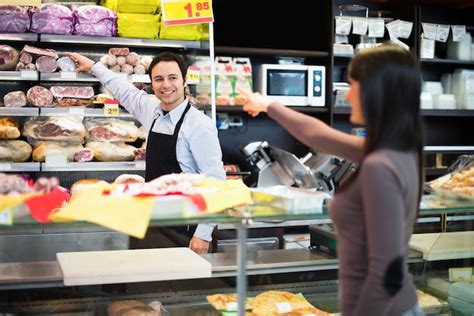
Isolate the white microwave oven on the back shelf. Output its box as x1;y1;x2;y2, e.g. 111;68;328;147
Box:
256;64;326;106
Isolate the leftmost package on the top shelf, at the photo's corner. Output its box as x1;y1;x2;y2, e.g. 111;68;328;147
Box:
0;4;31;33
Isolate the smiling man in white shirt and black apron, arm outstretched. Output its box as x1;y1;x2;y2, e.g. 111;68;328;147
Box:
66;52;225;253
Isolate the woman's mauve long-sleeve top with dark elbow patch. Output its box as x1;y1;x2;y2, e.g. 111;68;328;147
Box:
268;102;419;316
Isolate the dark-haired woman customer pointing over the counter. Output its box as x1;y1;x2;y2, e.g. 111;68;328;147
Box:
242;44;423;316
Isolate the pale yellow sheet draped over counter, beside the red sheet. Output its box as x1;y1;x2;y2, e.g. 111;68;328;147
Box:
50;185;155;238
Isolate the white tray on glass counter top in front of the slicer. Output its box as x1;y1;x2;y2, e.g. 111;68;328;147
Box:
250;185;331;213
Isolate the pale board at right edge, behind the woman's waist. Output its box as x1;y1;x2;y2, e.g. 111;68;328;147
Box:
410;232;474;261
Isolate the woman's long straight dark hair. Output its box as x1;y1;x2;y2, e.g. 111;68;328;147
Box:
349;44;424;197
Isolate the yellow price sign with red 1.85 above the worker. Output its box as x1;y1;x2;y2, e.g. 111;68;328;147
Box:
161;0;214;26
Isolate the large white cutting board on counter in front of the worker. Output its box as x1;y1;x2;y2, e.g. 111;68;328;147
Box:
56;248;212;286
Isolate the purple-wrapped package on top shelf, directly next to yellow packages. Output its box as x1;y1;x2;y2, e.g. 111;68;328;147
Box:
74;5;117;36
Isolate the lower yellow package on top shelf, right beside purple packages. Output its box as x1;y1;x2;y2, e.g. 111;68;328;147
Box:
117;13;160;39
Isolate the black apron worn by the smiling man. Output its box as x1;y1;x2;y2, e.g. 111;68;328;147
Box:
130;103;196;249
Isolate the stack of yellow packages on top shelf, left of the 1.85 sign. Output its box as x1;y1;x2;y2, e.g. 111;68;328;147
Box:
101;0;160;39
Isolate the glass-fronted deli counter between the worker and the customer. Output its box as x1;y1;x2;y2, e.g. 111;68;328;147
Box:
0;195;474;315
